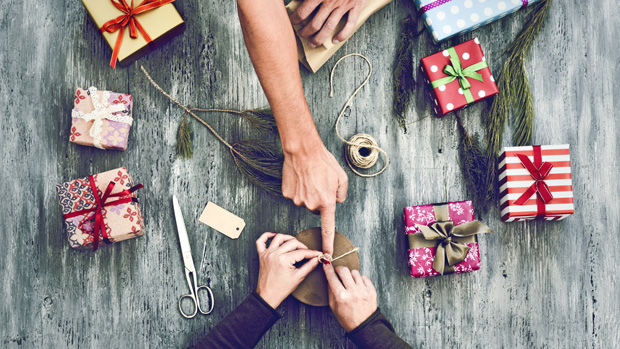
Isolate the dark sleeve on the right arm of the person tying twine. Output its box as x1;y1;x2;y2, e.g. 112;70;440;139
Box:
347;308;412;349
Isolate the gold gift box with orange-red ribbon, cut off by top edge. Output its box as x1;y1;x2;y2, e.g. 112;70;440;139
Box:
82;0;185;68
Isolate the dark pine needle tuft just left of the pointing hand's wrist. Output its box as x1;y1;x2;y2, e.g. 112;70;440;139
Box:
230;140;284;196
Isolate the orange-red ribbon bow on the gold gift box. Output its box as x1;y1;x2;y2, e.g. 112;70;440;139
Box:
99;0;174;68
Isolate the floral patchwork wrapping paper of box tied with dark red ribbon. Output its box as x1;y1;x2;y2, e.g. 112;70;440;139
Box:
56;167;144;250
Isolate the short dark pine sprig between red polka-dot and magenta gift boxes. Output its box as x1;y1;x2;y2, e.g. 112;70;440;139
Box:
455;114;489;214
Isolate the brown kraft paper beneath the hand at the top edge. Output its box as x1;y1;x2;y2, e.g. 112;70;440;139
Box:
286;0;392;73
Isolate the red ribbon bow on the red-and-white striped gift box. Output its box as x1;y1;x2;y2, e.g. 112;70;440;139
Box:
514;145;553;218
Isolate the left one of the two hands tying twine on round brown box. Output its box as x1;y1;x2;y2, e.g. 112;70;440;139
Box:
256;233;321;309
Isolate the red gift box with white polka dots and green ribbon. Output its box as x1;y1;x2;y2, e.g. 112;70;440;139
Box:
420;38;498;117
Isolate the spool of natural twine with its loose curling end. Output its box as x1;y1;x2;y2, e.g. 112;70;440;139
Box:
329;53;390;178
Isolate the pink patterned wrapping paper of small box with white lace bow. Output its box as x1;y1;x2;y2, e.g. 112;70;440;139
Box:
70;88;133;150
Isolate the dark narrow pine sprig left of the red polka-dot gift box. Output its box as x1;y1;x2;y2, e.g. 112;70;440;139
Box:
393;15;417;130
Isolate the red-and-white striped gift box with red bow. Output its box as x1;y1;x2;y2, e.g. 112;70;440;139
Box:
498;144;575;222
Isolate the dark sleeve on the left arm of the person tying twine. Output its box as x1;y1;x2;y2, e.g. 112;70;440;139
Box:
194;292;281;348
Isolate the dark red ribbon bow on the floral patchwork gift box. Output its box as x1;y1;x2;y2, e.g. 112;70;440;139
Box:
64;176;144;252
